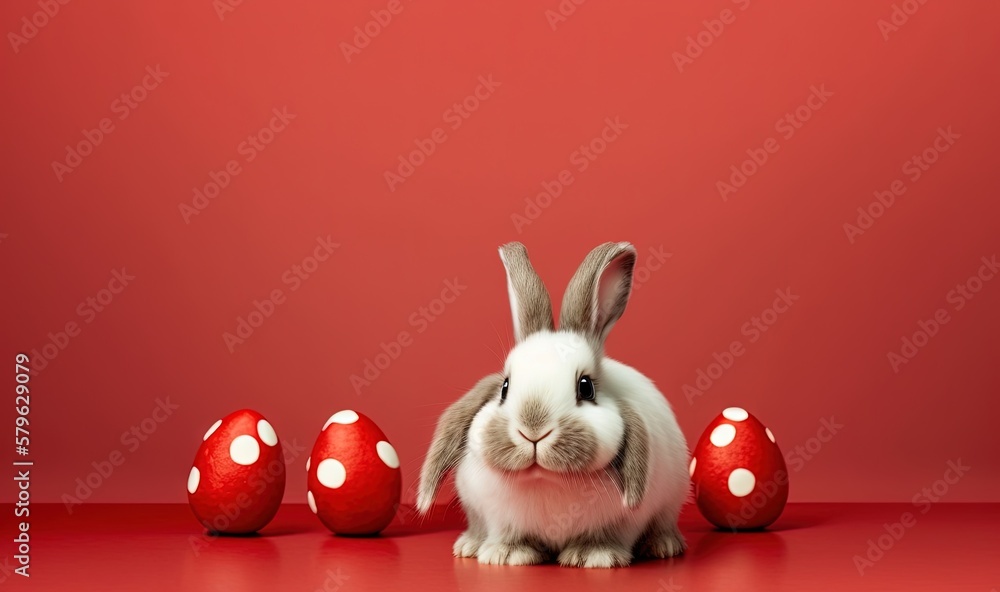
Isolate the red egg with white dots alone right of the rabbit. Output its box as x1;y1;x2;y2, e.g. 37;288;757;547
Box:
688;407;788;530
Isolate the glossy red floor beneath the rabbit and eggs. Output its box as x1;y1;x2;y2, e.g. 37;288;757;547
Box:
9;504;1000;592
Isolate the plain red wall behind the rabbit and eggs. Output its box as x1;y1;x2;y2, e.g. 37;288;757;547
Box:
0;0;1000;503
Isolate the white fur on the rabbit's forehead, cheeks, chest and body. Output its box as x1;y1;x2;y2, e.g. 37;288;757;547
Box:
455;331;689;565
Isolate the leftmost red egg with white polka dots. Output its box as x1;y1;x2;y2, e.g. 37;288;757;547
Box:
187;409;285;534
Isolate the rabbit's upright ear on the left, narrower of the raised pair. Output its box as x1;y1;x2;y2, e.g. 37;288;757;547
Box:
500;243;554;342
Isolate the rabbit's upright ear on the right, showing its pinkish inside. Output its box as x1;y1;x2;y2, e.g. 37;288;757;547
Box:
559;243;636;345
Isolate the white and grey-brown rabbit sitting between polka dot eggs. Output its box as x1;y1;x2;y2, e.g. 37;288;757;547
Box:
417;242;690;568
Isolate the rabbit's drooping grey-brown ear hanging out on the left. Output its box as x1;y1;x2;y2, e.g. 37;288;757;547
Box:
417;374;504;514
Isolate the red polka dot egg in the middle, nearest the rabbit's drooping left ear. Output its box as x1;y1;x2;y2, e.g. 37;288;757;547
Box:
306;410;402;535
